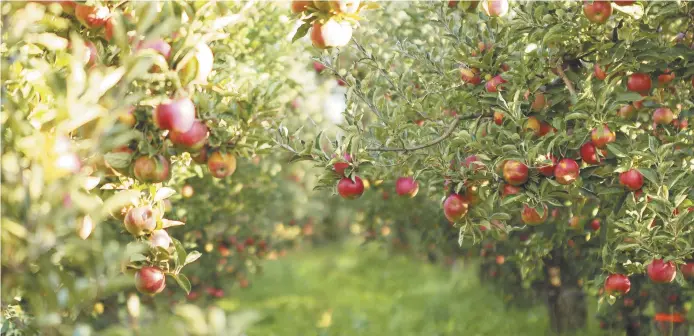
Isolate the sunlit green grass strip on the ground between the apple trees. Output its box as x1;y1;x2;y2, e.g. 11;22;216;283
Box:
218;246;604;336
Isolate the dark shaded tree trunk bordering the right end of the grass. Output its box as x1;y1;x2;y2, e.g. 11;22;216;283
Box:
544;251;588;335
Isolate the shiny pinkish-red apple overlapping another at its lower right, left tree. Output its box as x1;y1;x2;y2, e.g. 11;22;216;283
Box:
154;98;195;132
